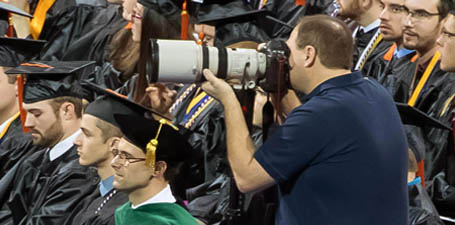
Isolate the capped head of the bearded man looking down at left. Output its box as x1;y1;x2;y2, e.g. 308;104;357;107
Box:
7;61;93;148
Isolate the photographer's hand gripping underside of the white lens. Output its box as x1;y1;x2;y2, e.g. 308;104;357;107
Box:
201;69;237;105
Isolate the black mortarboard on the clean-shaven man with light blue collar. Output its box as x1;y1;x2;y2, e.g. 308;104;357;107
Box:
83;82;170;121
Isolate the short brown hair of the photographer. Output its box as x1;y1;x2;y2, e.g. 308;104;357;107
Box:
296;15;354;69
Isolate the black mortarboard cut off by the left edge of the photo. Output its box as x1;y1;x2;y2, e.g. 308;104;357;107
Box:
0;37;46;67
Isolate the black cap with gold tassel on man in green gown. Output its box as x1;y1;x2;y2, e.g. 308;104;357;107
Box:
114;114;192;169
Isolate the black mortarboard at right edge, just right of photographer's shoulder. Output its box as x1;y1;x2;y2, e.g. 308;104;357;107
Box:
395;103;452;130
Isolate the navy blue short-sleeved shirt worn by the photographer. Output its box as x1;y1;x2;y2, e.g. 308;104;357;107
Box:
255;72;408;225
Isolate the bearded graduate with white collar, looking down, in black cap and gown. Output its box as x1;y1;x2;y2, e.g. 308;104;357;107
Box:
0;61;96;225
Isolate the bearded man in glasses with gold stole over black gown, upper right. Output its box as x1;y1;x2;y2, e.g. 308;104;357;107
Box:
394;0;451;184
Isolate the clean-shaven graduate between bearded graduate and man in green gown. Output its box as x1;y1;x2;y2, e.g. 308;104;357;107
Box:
66;84;151;225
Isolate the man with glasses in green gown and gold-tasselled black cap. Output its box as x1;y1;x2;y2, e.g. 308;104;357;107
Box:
111;111;197;225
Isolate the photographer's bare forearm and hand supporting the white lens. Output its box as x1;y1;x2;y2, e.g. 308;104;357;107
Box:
201;69;275;192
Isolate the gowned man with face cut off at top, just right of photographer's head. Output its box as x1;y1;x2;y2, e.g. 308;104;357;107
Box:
337;0;392;78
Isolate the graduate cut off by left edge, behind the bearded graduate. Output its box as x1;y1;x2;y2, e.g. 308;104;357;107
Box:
0;37;46;178
